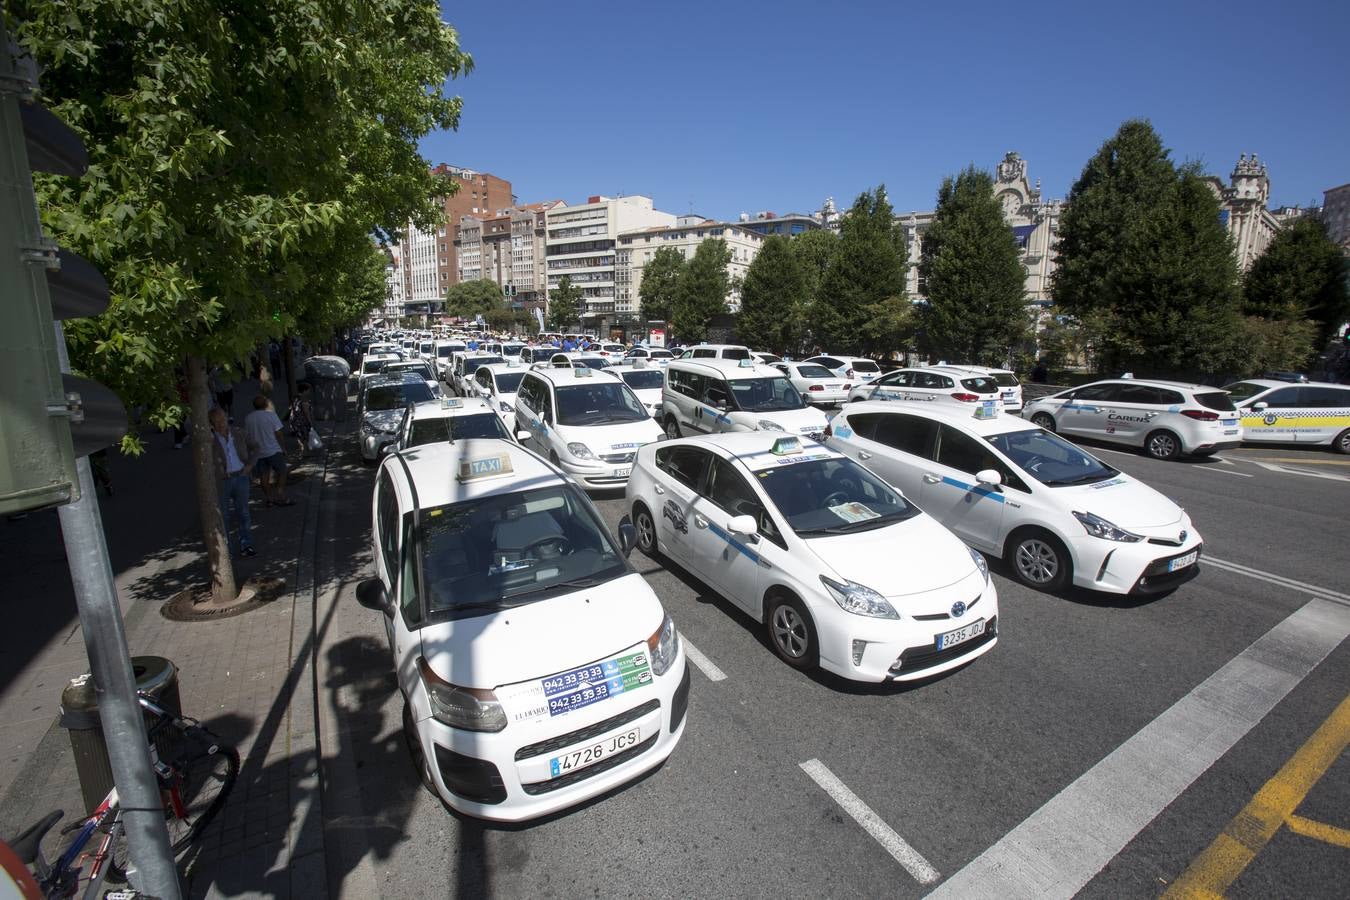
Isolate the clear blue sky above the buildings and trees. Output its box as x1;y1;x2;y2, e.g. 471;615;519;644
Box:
421;0;1350;219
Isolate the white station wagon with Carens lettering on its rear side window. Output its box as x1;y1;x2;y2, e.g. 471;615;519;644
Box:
1022;378;1242;459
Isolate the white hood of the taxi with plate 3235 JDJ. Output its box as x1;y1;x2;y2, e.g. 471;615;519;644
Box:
806;513;984;599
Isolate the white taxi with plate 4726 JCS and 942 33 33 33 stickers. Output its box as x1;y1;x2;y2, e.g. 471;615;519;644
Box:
356;440;689;822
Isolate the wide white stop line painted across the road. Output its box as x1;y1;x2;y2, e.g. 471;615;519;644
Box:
929;599;1350;900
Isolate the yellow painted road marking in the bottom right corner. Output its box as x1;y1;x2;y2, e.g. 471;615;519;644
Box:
1162;696;1350;899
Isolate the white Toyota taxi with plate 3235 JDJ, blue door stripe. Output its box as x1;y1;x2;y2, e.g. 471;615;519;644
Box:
625;432;999;681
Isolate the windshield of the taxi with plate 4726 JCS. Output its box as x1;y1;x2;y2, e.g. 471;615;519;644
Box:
419;486;629;618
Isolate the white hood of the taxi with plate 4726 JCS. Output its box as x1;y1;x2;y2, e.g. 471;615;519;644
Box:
421;572;664;688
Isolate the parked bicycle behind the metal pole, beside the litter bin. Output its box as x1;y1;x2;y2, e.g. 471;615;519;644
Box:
8;694;239;900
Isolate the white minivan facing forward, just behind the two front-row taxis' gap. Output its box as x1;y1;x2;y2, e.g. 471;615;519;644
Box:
516;363;662;488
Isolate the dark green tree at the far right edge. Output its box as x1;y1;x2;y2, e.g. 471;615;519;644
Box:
1242;216;1350;354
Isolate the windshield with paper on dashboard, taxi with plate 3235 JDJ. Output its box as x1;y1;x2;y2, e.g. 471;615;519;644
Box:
755;456;918;537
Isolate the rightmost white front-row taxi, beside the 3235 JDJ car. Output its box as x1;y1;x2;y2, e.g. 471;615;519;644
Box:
825;402;1202;594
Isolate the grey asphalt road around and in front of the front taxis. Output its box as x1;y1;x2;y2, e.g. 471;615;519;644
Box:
319;423;1350;897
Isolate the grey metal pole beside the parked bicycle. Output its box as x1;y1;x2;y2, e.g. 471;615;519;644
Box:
55;322;182;900
